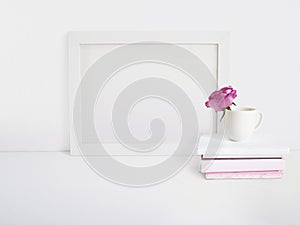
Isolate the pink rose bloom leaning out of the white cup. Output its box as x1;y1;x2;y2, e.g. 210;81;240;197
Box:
205;86;237;112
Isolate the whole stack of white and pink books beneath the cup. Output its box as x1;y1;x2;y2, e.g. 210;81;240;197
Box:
198;136;289;179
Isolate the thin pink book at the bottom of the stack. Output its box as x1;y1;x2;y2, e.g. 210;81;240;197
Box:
204;170;283;180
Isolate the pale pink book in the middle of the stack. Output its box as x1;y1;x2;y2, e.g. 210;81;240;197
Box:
201;158;285;173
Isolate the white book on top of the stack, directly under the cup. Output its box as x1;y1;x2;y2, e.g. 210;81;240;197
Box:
198;136;289;158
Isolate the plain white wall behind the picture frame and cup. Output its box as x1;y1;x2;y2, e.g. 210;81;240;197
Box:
0;0;300;151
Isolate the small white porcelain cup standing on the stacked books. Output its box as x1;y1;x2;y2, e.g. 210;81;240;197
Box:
225;107;262;141
